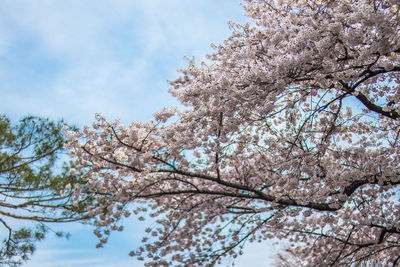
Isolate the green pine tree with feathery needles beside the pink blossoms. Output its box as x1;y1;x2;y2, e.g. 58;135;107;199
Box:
0;115;90;266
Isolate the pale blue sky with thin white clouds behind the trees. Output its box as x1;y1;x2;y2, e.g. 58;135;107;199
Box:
0;0;276;267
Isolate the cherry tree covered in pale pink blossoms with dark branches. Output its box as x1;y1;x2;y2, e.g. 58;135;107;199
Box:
67;0;400;266
